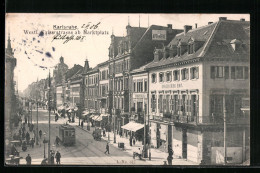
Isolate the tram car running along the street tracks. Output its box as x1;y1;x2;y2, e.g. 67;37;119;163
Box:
59;124;76;146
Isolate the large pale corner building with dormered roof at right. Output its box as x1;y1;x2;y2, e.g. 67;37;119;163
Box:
146;17;250;164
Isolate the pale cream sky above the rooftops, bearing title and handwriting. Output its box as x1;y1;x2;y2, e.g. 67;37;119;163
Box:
5;13;250;91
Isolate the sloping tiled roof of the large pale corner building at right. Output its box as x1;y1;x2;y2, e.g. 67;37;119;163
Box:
146;20;250;69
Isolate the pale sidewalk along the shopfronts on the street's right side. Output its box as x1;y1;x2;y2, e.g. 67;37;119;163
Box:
62;118;198;165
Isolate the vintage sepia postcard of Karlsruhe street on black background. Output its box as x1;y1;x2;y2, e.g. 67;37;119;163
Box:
4;13;250;167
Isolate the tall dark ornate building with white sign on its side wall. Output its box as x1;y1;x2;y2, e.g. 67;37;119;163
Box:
109;24;181;131
